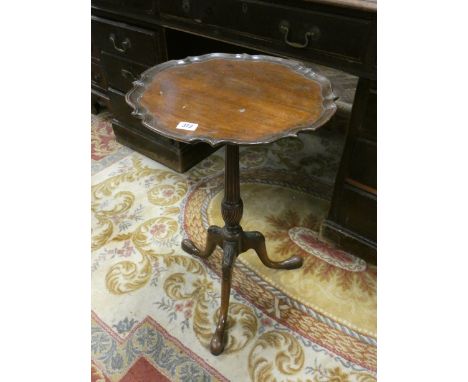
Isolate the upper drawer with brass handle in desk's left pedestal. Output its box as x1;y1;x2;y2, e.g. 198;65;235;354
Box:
91;16;163;65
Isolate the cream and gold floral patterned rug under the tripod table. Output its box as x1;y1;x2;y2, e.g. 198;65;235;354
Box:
91;113;377;382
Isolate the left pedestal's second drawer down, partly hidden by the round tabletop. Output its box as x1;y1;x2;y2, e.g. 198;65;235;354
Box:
101;52;148;93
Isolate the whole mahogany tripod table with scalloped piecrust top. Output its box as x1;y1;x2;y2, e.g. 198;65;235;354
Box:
126;54;336;355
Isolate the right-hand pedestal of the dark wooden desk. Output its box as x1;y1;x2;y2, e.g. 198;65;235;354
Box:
321;78;377;264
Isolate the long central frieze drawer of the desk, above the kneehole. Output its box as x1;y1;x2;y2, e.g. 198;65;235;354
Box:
159;0;373;66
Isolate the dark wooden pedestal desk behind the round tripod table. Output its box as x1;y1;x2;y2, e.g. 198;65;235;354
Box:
91;0;377;263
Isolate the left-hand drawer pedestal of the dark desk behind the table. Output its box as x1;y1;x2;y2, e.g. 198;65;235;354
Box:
91;13;218;172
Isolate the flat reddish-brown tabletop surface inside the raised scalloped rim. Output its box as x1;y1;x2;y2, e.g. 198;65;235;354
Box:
140;58;330;143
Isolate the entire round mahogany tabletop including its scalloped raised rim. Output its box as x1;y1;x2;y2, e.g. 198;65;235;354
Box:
126;53;336;146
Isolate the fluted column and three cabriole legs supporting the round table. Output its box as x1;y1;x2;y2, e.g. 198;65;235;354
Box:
182;144;302;355
